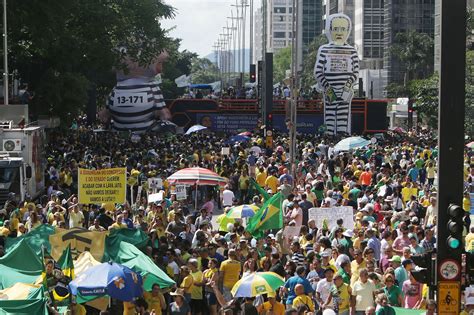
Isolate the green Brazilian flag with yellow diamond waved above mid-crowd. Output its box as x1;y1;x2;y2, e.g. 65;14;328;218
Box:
247;193;283;238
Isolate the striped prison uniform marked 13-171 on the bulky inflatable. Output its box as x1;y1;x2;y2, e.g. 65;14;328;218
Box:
107;79;166;132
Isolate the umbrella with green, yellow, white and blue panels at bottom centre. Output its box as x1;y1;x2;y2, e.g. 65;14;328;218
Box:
231;272;285;298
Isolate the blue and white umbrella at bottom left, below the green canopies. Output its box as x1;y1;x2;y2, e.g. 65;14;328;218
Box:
69;262;143;301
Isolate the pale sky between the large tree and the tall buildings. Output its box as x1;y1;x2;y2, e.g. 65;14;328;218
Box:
161;0;248;57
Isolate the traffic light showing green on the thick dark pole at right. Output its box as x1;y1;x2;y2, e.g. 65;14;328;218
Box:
447;204;464;259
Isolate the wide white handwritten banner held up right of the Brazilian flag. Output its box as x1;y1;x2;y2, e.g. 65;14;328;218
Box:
308;207;354;230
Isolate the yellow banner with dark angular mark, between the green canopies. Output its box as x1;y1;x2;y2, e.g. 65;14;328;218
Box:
49;228;108;261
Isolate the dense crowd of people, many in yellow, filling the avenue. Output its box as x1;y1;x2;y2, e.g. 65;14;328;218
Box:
0;125;474;315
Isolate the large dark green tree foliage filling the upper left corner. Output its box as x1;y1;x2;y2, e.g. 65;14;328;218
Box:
7;0;173;121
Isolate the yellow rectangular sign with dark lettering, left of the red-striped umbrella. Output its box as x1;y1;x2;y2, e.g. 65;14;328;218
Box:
78;168;127;204
